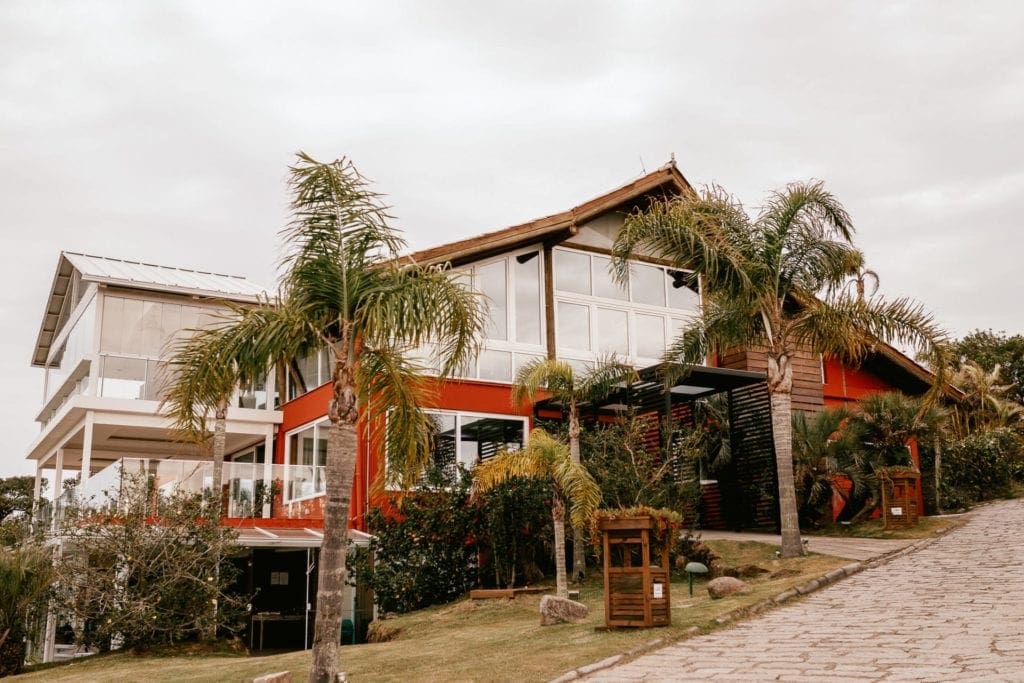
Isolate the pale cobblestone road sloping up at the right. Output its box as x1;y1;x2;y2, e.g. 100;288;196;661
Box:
588;501;1024;681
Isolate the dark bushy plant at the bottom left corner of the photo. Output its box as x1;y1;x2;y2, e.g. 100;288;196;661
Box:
0;546;53;676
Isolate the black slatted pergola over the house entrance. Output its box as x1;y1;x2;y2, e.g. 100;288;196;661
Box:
535;364;779;529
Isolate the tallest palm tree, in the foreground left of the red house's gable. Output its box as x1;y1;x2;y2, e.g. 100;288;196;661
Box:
165;153;486;681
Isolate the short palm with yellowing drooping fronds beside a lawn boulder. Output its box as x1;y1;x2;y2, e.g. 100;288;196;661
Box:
473;429;601;598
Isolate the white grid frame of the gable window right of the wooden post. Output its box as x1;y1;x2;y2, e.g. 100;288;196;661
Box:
552;247;702;367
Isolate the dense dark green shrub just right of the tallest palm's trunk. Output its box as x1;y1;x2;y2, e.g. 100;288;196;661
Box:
348;468;480;612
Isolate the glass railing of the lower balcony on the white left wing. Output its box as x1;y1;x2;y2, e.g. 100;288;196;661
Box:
46;458;325;528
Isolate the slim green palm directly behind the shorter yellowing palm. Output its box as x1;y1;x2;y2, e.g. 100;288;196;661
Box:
512;356;635;583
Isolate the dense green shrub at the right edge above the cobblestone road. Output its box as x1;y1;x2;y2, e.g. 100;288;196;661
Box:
942;429;1024;509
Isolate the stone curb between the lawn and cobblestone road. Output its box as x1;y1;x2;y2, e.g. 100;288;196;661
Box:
549;520;967;683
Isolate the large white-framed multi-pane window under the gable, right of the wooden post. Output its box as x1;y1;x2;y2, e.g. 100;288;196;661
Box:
554;248;700;365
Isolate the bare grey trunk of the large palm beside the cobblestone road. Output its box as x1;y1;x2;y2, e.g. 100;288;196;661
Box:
768;354;804;557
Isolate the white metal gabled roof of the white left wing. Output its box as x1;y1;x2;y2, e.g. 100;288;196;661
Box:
32;252;267;367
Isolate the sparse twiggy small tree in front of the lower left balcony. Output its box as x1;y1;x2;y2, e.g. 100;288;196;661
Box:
56;476;244;647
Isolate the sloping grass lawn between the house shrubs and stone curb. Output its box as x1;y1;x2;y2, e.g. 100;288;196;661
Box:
16;541;849;683
